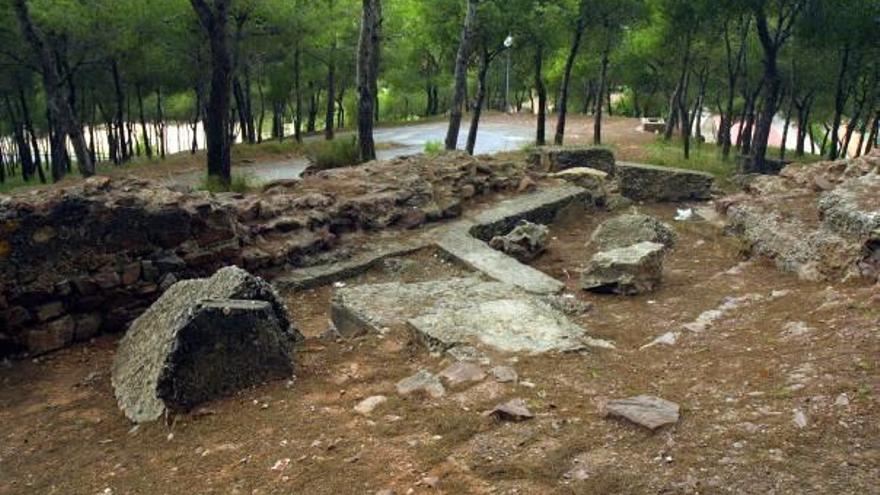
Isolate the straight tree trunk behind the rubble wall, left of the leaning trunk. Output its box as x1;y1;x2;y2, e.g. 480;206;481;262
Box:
357;0;382;162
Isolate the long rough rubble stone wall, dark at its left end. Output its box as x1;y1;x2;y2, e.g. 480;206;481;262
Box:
0;154;524;356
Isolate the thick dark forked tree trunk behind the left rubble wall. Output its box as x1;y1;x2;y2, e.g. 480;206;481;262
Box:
190;0;233;187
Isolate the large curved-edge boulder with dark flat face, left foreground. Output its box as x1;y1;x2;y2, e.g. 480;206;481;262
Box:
112;266;302;423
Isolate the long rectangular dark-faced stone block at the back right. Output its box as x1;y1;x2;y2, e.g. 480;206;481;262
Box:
617;162;715;201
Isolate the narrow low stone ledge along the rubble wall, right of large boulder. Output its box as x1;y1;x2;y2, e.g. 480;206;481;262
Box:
273;242;428;291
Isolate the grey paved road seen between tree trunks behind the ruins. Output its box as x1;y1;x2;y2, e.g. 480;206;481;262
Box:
217;122;534;186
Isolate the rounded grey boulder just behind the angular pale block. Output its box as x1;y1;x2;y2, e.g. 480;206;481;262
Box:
590;213;678;251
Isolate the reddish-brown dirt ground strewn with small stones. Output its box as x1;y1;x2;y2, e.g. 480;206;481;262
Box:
0;199;880;495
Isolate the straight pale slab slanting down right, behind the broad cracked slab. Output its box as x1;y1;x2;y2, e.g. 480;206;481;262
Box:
437;229;565;294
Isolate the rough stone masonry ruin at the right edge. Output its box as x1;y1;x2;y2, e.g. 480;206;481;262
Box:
716;149;880;280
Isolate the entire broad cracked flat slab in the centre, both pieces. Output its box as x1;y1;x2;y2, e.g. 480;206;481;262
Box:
331;277;613;352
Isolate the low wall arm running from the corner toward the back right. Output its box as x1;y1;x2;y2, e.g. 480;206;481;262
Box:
470;186;590;242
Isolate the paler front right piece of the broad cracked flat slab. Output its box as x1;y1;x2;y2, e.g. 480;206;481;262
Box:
408;298;613;353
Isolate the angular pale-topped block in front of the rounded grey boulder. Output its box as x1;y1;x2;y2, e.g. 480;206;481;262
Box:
581;242;665;295
